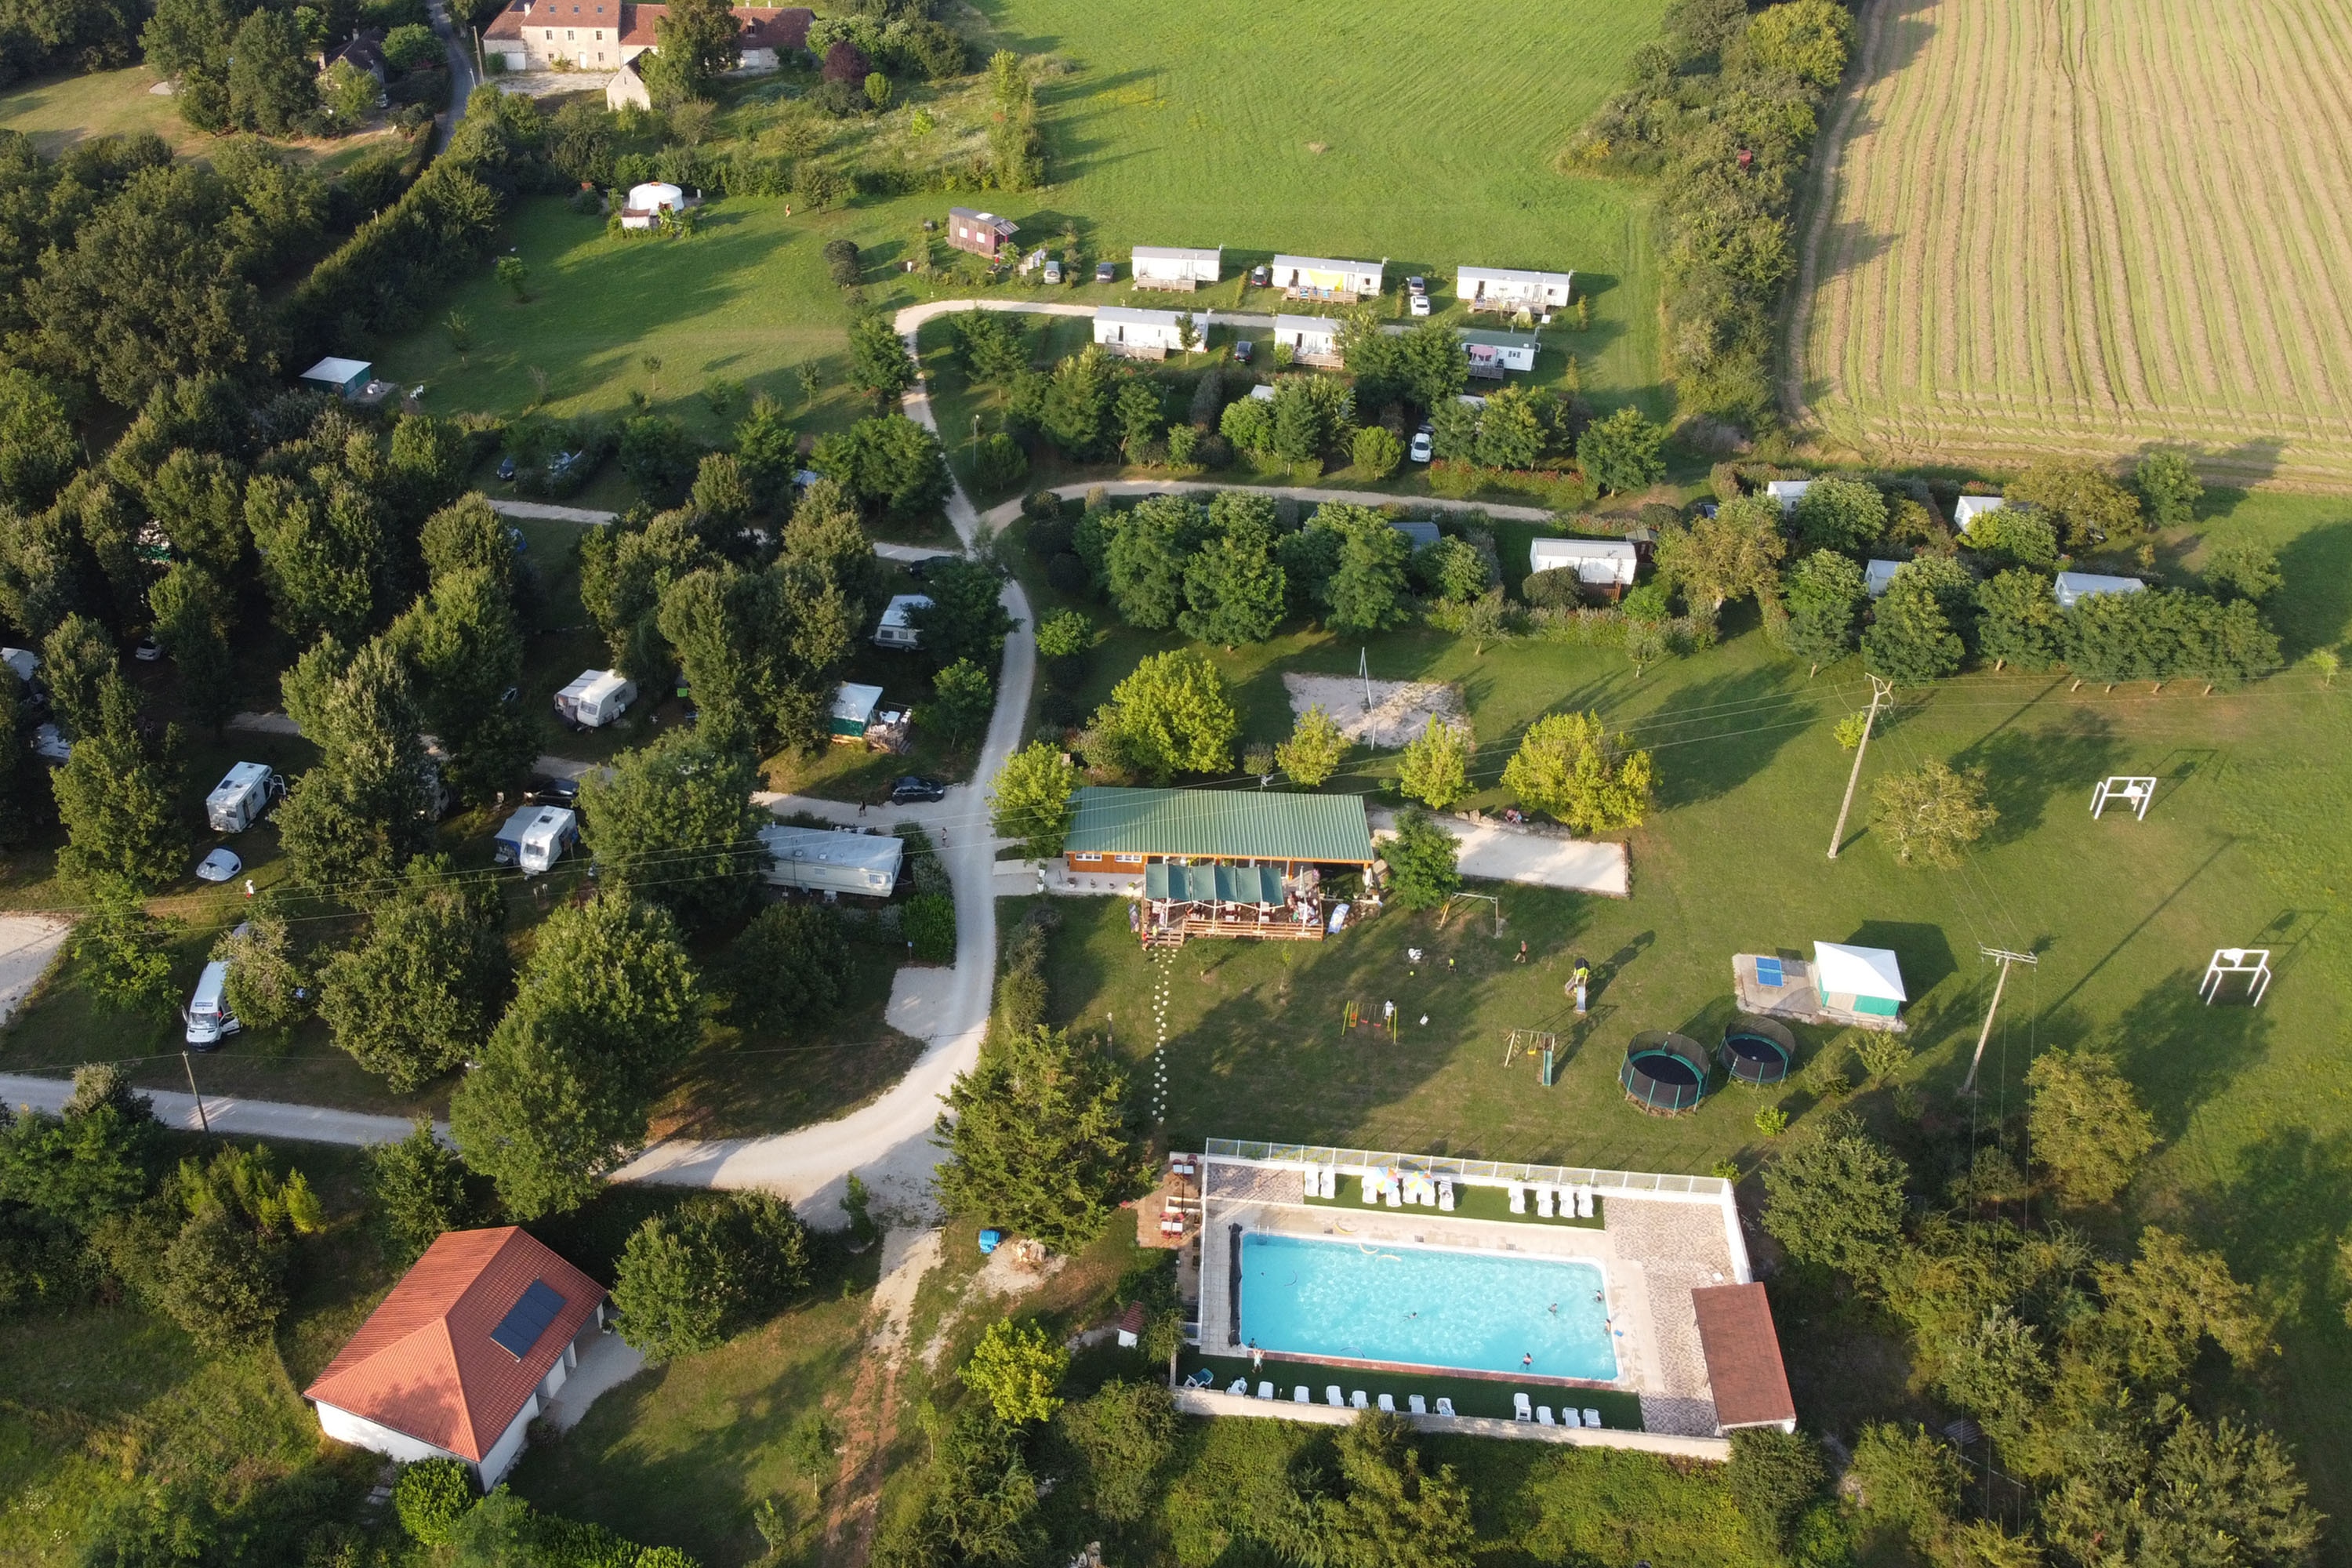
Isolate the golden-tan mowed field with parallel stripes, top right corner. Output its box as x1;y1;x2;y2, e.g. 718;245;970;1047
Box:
1785;0;2352;489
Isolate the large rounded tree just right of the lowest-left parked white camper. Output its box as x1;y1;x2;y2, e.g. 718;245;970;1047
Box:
325;855;513;1093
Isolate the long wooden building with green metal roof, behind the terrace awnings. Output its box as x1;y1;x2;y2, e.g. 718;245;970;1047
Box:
1063;787;1371;874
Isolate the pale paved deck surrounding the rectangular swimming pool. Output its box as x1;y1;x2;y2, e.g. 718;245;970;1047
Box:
1200;1163;1738;1439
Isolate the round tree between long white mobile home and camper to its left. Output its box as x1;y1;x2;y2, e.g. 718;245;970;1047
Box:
581;731;771;928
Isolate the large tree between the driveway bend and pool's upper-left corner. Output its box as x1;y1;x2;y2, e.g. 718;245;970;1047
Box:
931;1025;1148;1250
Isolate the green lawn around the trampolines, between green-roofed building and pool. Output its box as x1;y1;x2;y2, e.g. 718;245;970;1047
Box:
1004;494;2352;1516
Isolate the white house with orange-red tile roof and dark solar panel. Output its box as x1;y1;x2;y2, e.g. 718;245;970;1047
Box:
303;1225;604;1490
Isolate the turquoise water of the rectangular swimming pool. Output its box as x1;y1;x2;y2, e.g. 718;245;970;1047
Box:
1242;1234;1618;1382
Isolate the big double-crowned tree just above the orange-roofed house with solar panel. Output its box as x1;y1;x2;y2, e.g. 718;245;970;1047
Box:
449;888;701;1220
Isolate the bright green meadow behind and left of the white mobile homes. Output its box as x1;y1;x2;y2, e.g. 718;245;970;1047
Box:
360;0;1663;510
